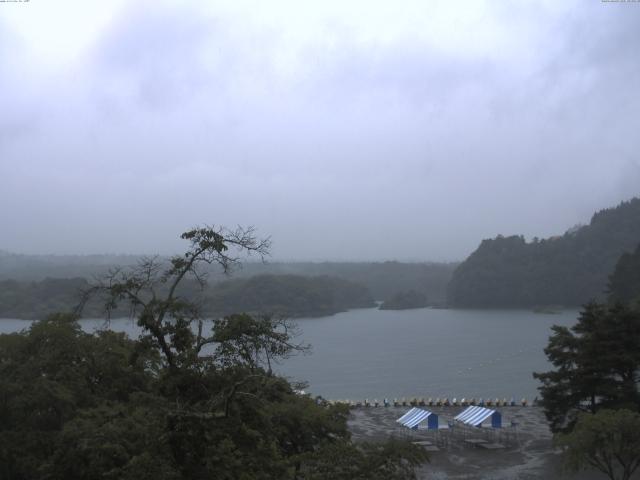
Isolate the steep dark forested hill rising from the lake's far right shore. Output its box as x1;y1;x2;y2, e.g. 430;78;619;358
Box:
447;198;640;308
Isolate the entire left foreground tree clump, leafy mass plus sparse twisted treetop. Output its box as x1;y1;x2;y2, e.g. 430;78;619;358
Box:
0;228;426;480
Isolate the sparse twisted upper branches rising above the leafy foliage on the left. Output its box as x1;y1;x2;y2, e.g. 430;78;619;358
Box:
78;227;270;368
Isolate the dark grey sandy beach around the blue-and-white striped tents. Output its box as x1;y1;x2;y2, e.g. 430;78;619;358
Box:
349;406;616;480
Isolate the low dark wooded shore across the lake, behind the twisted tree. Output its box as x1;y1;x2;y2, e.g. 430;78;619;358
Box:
0;275;374;319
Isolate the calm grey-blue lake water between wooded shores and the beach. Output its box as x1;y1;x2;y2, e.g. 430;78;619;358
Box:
0;309;578;400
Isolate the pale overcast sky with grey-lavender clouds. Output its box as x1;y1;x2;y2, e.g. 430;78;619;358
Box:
0;0;640;260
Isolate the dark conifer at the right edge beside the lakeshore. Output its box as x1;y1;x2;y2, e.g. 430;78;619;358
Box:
534;303;640;432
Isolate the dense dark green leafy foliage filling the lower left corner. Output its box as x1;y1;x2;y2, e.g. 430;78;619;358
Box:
0;315;426;480
